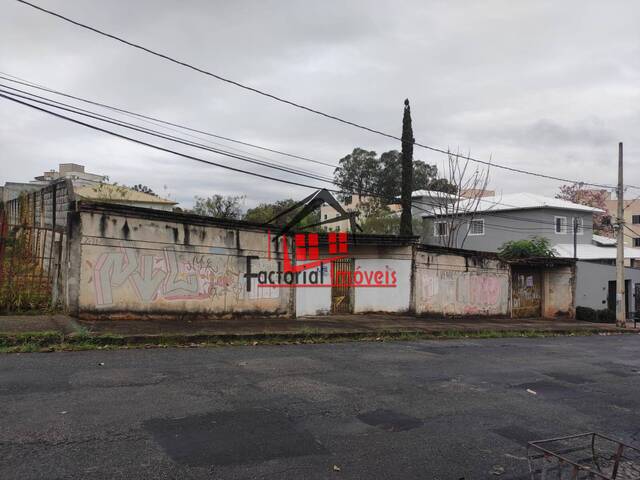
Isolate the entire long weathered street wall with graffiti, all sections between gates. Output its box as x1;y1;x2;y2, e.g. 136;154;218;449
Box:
62;202;573;318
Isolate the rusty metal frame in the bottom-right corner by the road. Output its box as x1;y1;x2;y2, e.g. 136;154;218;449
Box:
527;432;640;480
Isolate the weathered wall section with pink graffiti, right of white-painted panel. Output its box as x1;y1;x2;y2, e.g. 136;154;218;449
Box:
414;251;510;315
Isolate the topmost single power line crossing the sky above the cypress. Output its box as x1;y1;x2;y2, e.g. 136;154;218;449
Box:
17;0;613;188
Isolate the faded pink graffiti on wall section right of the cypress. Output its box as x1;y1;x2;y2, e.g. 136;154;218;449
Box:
419;271;507;314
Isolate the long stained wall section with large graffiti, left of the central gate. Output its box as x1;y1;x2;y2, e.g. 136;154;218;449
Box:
68;206;291;317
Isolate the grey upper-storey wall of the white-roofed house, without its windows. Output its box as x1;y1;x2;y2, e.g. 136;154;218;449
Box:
421;208;593;252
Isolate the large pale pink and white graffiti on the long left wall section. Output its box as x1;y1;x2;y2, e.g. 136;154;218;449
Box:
89;247;278;306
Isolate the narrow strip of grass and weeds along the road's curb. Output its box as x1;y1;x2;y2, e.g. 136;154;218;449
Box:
0;327;601;353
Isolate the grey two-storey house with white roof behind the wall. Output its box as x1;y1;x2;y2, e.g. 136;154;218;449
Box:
422;193;640;315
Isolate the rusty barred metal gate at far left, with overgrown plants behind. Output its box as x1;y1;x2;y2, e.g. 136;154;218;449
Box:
0;206;65;312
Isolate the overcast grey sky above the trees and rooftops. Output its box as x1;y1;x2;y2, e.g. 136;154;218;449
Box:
0;0;640;206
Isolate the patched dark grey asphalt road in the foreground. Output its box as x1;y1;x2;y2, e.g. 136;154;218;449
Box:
0;335;640;480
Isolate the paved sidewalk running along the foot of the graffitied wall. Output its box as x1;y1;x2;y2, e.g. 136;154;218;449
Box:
0;314;640;337
